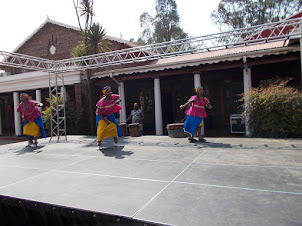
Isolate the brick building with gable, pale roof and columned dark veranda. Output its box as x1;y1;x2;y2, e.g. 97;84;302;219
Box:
0;14;301;136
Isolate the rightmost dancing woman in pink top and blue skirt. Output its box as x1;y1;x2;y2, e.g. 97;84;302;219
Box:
180;86;212;142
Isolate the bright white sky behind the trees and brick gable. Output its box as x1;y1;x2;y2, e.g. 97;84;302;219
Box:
0;0;220;52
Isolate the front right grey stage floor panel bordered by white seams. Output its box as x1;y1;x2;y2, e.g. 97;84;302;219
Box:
136;183;302;226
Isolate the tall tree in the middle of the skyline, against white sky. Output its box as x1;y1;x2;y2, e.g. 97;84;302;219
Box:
138;0;188;44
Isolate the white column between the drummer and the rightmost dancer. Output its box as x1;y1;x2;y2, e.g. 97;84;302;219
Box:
154;78;163;135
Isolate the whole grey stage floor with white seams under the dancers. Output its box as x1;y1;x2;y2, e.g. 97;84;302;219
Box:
0;136;302;226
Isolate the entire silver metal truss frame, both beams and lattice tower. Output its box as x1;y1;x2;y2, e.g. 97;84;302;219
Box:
0;18;302;141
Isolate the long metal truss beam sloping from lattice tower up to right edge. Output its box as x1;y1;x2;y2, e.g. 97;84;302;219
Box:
57;18;301;71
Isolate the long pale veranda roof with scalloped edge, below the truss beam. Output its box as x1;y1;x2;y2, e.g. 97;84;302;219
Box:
92;41;300;78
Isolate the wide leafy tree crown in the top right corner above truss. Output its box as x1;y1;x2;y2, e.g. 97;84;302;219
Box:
211;0;302;29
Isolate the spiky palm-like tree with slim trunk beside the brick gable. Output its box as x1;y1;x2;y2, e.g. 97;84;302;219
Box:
71;0;110;135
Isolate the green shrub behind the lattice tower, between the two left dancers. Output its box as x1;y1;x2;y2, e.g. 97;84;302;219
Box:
43;98;82;136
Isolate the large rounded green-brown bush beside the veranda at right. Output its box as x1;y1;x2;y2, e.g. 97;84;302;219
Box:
241;80;302;138
